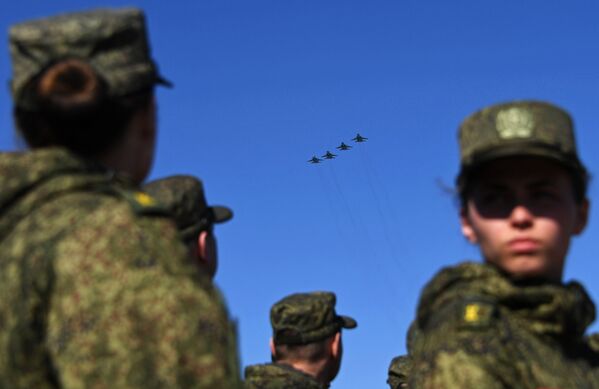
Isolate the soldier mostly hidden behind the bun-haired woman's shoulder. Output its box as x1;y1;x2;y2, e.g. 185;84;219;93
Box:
143;176;233;278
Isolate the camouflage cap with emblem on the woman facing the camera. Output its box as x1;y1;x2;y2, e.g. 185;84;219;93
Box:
458;101;586;186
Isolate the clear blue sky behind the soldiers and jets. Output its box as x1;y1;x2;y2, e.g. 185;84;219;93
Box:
0;0;599;388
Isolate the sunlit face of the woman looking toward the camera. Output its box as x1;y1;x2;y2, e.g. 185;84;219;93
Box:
461;157;588;280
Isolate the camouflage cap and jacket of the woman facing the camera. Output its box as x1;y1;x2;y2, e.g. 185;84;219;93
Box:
408;102;599;389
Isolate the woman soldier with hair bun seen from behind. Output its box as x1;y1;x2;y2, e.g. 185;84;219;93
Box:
0;9;240;389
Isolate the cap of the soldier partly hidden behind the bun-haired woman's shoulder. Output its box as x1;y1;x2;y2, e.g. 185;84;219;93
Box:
143;175;233;240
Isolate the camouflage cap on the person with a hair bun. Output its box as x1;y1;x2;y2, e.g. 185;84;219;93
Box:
9;8;170;106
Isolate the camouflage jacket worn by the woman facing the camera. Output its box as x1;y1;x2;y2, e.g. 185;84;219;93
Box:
408;263;599;389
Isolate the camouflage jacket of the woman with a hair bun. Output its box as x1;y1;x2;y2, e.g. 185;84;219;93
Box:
0;148;240;389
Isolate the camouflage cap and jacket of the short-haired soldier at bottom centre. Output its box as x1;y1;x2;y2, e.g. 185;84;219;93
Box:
245;292;358;389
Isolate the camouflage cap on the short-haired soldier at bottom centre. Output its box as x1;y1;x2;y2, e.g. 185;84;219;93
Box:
270;292;358;345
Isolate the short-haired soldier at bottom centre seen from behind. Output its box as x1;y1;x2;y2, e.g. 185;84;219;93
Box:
245;292;357;389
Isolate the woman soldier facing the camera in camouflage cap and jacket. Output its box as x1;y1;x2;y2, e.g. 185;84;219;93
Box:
409;101;599;389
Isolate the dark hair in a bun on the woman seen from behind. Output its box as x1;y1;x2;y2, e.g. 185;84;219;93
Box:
14;59;153;156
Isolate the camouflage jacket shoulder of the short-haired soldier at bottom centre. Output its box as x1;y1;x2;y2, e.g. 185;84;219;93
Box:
245;363;328;389
